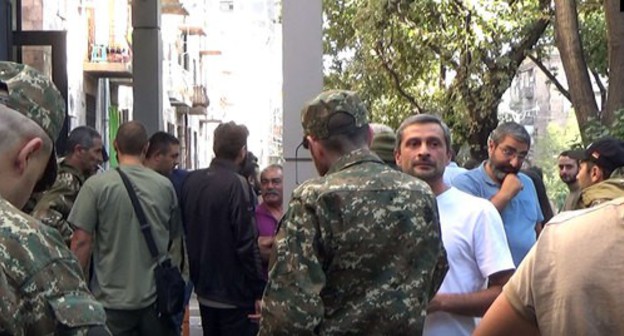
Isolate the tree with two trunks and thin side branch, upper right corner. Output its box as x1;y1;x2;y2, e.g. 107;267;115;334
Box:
529;0;624;143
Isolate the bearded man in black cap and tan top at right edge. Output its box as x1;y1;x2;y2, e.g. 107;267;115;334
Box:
569;136;624;209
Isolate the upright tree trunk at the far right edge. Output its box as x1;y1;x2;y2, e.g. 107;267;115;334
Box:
602;0;624;125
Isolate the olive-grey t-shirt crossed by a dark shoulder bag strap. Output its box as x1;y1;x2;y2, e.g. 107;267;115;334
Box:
68;166;182;309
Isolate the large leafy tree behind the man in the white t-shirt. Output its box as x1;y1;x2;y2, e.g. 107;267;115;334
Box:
324;0;552;160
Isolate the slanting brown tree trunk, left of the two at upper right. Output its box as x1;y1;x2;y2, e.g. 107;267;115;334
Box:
555;0;610;142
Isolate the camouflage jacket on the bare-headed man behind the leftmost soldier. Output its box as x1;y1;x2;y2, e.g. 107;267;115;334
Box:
32;160;86;245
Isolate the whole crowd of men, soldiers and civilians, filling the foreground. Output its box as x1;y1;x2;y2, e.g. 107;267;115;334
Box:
0;62;624;336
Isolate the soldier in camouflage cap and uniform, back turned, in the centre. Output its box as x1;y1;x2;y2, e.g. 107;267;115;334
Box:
260;90;446;335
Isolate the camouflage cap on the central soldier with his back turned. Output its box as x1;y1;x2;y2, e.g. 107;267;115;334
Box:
301;90;368;139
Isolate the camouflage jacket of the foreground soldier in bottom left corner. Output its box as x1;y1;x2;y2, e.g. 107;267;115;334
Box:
0;198;106;336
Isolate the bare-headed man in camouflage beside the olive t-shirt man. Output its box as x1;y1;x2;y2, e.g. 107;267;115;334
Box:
32;126;103;246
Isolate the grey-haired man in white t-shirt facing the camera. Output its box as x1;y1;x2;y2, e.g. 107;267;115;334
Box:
395;114;514;335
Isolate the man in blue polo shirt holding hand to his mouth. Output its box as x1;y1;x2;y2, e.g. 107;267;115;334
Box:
452;122;544;267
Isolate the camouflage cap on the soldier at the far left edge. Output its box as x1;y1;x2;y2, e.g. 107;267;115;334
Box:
0;61;65;191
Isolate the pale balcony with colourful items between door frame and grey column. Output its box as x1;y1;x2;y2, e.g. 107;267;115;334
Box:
83;44;132;78
